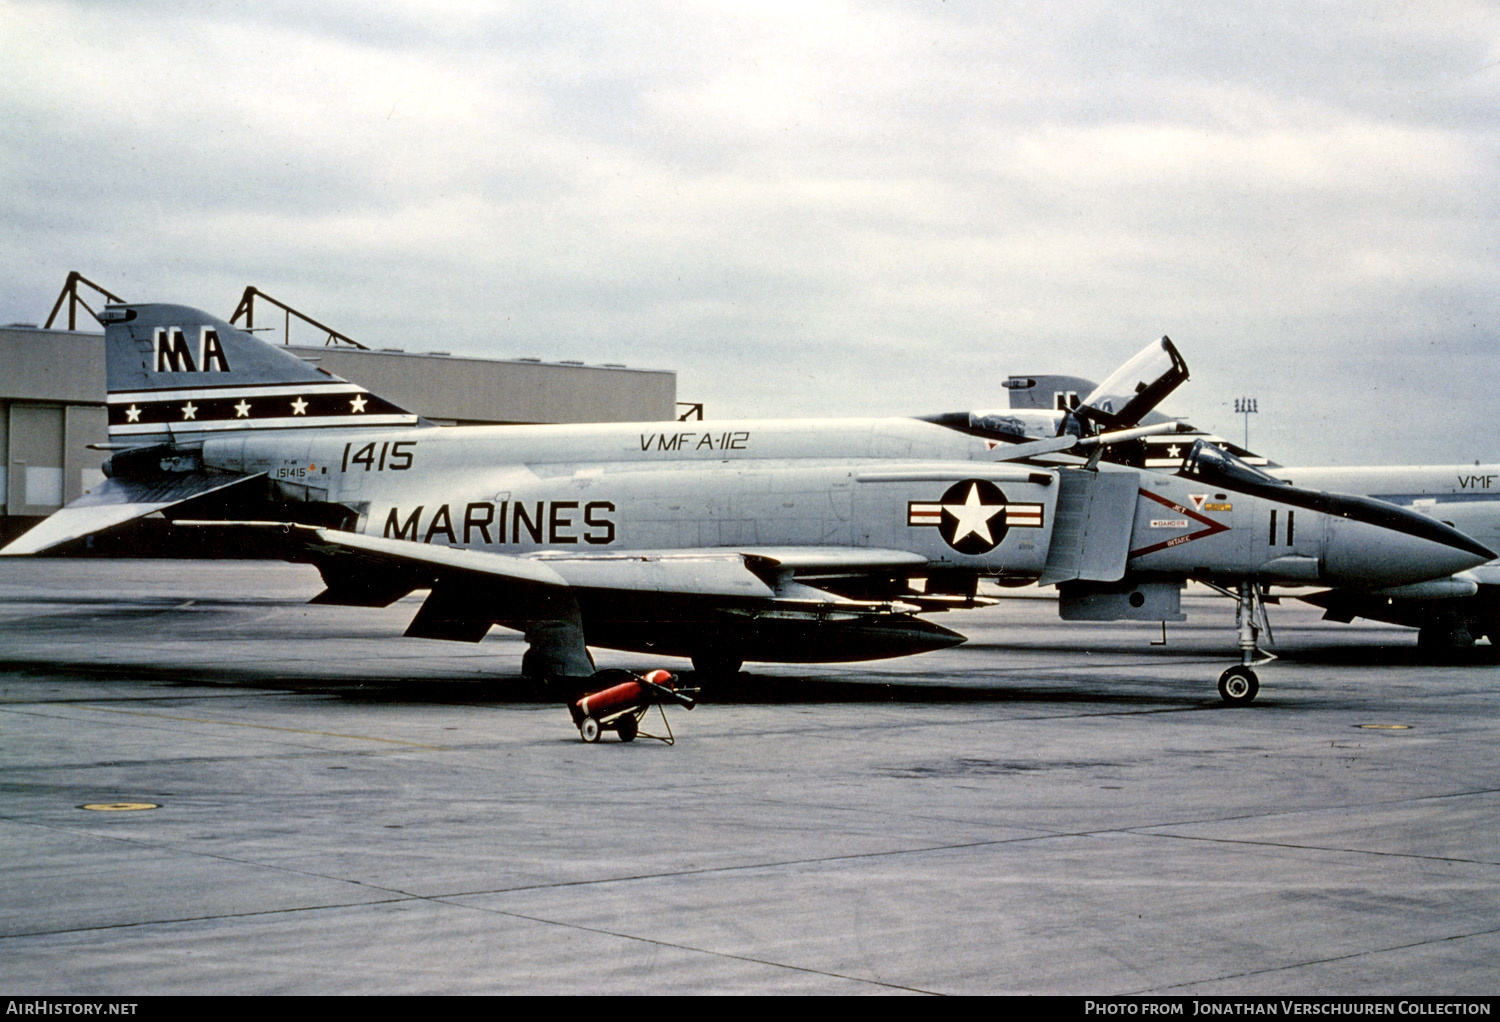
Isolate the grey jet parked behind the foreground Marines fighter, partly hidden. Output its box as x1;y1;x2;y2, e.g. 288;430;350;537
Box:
1002;375;1500;651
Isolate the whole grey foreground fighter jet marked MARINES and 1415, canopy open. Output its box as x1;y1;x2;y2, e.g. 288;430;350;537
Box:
3;298;1494;702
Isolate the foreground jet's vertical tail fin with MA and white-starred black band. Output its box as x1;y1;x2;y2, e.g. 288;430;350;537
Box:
99;305;417;444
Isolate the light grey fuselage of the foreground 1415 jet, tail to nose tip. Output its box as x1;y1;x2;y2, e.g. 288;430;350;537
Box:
203;417;1485;585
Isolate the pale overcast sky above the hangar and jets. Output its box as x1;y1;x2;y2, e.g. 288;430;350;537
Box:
0;0;1500;464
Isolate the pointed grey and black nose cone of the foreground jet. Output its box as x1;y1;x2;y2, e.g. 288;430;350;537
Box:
1323;498;1496;587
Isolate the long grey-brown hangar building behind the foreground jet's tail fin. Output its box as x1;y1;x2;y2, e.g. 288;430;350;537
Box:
0;315;677;543
